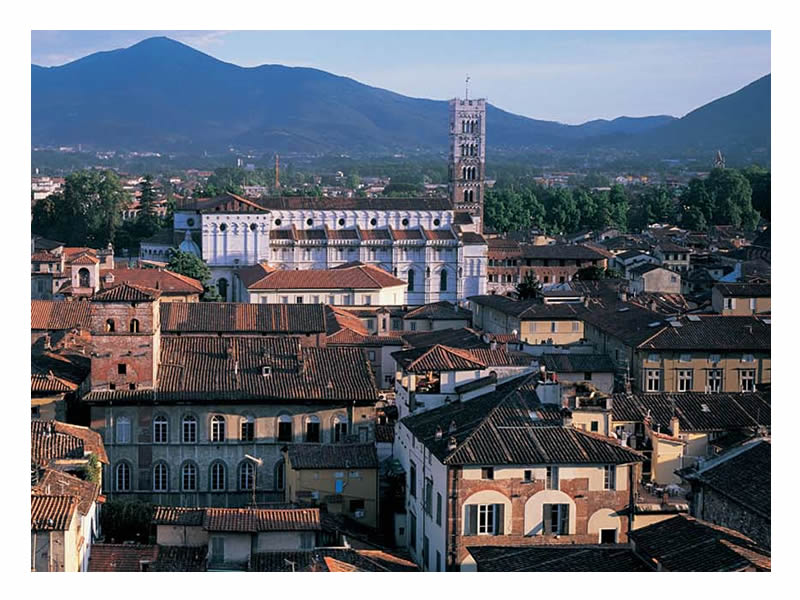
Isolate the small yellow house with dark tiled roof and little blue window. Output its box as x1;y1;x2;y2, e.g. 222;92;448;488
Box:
284;444;378;527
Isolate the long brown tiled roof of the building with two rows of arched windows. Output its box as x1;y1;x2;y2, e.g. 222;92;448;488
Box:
84;336;378;403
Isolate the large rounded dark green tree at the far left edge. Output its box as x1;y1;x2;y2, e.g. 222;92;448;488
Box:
32;170;130;248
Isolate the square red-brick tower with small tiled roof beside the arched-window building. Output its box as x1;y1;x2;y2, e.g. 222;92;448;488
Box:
91;283;161;390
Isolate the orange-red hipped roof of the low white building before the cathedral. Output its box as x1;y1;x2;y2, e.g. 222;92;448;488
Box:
240;264;406;290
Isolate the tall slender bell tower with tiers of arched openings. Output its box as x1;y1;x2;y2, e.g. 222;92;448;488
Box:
449;82;486;231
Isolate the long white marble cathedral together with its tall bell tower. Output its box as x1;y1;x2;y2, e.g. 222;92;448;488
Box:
147;99;488;305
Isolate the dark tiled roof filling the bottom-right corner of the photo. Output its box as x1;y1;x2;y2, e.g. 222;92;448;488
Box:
628;515;772;572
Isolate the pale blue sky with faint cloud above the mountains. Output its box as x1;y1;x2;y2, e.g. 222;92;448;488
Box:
31;30;770;124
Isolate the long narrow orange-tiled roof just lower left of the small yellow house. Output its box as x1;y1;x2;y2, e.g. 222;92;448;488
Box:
203;508;321;533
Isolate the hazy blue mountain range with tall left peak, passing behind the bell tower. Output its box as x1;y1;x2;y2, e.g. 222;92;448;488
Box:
31;37;764;159
